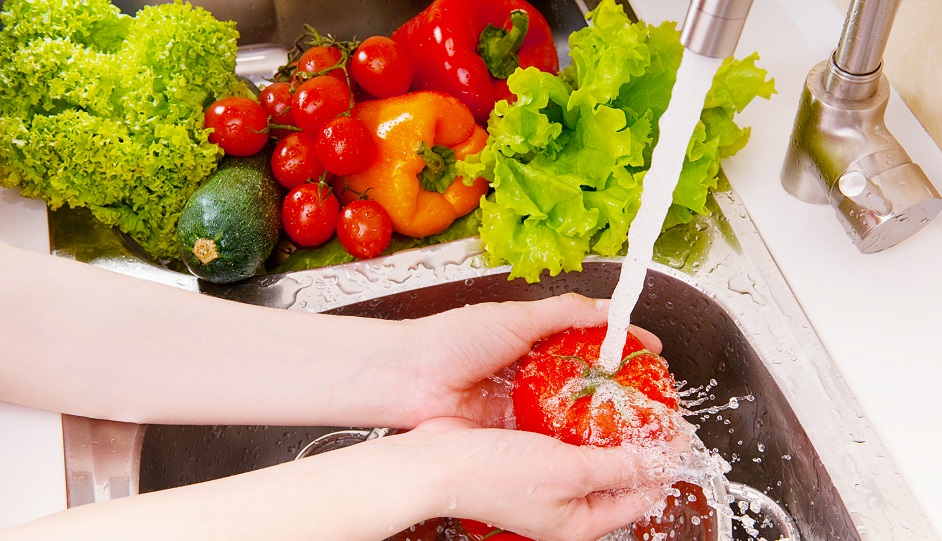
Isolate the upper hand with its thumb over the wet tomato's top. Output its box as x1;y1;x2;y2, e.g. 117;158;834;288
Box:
390;293;661;428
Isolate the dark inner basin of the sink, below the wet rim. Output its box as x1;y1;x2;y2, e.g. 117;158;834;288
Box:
140;258;824;539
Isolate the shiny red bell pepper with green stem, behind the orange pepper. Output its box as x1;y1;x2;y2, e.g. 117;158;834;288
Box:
392;0;559;125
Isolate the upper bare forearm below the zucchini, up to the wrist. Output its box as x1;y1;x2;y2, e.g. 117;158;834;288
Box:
0;243;422;426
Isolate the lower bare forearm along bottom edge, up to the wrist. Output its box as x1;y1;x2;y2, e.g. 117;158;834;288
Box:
0;434;444;541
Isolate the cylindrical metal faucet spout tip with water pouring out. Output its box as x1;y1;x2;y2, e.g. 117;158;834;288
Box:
680;0;752;58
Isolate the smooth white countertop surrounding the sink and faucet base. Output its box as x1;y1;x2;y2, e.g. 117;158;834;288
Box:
0;0;942;533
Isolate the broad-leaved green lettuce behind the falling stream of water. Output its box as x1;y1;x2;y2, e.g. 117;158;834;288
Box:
459;0;775;282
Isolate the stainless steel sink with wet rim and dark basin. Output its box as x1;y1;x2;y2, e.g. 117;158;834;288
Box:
57;0;934;541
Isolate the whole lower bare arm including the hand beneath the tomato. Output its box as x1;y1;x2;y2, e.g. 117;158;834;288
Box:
0;419;673;541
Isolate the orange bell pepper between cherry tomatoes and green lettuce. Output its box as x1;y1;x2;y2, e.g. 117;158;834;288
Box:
339;91;489;237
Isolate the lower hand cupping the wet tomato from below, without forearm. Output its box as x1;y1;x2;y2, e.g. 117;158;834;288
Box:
384;418;684;541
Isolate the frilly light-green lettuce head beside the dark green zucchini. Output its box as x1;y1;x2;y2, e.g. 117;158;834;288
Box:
0;0;247;259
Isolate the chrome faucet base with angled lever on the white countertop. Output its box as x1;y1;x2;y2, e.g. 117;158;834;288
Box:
782;0;942;253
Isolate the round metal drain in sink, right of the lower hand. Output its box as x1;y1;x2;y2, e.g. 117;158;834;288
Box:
726;482;801;541
